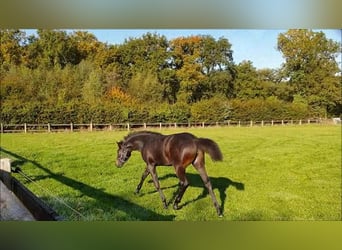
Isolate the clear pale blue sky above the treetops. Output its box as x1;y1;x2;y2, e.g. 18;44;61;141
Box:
25;29;341;69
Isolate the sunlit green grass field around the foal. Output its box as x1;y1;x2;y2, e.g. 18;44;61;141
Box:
1;125;341;221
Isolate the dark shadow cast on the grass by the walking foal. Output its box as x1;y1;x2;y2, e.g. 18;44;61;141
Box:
146;173;245;212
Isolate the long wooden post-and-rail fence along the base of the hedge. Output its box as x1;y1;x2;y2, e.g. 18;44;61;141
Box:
0;119;334;133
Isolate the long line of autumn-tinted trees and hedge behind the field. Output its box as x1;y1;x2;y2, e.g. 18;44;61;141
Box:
0;29;342;123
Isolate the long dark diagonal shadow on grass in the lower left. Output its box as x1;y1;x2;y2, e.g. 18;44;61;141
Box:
0;147;175;221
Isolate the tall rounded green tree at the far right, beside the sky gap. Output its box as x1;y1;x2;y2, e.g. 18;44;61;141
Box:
278;29;341;116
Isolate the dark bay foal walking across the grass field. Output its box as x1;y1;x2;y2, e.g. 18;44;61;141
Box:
116;131;223;216
